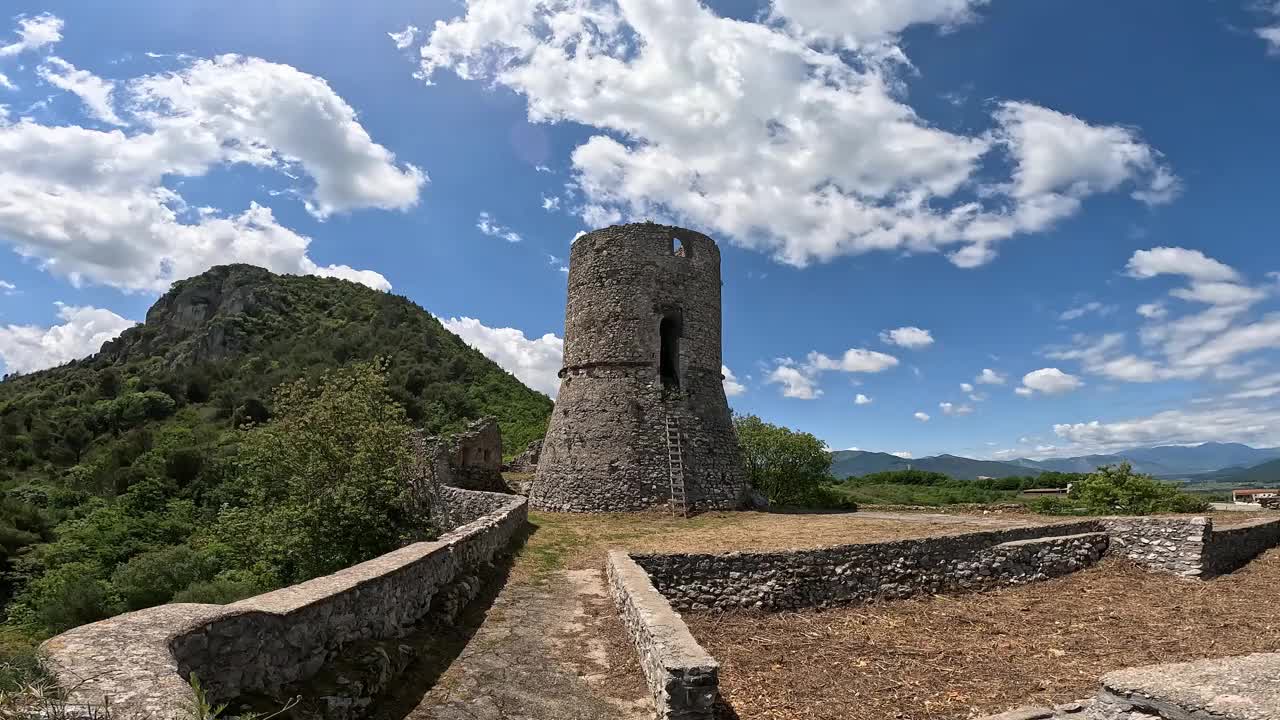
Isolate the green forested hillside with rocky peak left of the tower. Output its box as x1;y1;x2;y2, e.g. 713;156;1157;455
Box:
0;265;552;633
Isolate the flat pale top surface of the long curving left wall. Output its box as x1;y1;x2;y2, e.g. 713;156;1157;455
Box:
41;491;527;719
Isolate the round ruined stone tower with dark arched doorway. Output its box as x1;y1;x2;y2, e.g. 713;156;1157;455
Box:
529;223;749;512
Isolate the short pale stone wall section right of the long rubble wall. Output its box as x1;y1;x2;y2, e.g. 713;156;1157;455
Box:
1098;518;1213;578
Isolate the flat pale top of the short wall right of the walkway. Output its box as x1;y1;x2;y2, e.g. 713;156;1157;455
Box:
608;550;719;673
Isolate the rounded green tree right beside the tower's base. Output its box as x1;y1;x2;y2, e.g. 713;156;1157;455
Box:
733;415;832;505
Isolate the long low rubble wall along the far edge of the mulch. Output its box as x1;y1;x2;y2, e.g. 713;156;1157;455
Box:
632;521;1107;611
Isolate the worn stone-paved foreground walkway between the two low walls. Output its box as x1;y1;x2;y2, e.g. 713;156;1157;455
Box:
394;570;653;720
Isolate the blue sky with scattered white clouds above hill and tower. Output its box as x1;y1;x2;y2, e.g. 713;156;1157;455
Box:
0;0;1280;457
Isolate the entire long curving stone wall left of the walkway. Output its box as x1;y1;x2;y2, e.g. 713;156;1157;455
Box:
44;488;527;720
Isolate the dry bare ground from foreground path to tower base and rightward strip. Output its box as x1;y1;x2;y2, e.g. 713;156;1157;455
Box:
399;512;1070;720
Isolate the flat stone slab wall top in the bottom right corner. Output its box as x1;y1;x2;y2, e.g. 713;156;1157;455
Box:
1101;652;1280;720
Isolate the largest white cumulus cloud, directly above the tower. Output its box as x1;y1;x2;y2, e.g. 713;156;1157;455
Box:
407;0;1178;268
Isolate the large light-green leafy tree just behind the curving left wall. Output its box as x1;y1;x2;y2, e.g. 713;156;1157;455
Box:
211;363;430;585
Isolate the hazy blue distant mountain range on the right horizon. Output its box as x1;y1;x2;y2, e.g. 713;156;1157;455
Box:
831;442;1280;484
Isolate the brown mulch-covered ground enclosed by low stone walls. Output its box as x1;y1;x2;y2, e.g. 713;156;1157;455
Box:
685;550;1280;720
